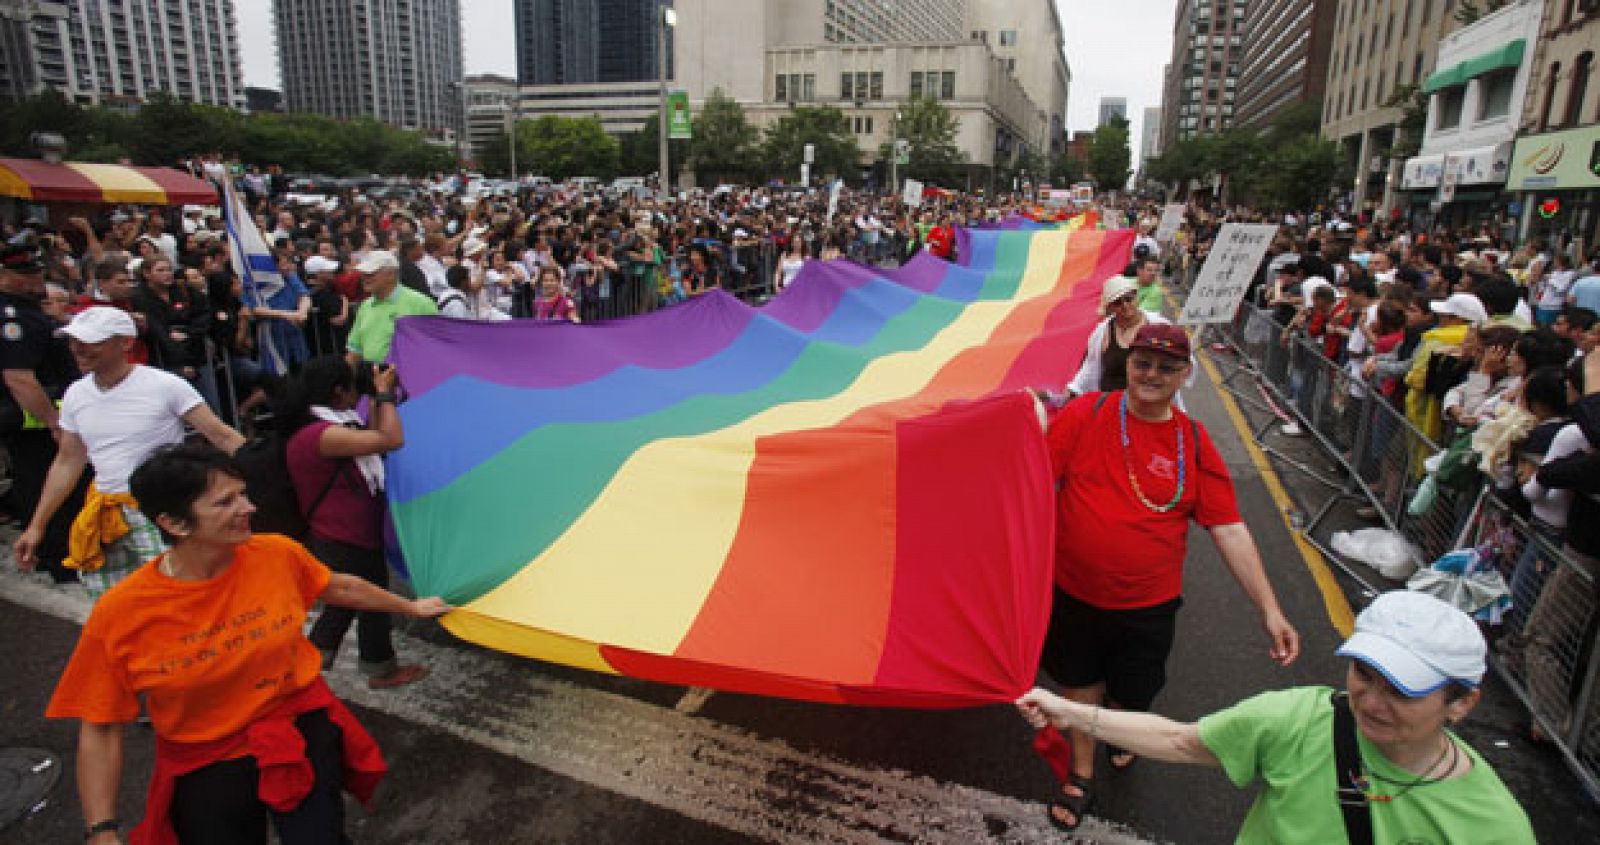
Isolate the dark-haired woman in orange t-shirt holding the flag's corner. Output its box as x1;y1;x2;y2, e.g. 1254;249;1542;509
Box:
46;445;450;845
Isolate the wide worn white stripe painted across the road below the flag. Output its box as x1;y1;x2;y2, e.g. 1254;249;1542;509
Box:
0;557;1149;845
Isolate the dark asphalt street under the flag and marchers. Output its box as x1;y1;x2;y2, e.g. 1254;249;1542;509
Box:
0;339;1600;843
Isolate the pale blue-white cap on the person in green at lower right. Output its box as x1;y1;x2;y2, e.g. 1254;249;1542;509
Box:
1338;591;1488;698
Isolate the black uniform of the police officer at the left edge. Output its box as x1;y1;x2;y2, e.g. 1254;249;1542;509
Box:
0;293;88;581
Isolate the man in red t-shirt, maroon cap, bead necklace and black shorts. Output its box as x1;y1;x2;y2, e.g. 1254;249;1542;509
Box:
1042;323;1299;829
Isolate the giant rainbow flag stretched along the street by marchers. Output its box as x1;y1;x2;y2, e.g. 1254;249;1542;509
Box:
389;227;1133;707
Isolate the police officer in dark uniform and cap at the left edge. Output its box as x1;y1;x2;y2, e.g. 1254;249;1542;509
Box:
0;243;83;583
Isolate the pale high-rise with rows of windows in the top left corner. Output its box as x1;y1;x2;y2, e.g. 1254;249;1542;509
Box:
0;0;245;109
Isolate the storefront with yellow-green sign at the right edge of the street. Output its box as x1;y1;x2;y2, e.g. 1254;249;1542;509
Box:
1506;125;1600;256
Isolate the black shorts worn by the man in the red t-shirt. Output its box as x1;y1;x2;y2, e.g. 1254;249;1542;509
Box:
1040;587;1184;711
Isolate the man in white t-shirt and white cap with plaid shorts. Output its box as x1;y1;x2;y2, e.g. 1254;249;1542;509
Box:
14;306;245;599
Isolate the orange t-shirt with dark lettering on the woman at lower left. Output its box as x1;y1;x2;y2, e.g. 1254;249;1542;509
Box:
45;535;331;743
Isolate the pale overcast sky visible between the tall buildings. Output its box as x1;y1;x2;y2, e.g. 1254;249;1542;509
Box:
235;0;1176;158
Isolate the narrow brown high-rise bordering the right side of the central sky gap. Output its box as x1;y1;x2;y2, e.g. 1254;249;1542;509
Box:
1162;0;1250;149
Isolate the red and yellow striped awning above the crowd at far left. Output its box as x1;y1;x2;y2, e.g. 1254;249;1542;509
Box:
0;158;216;205
